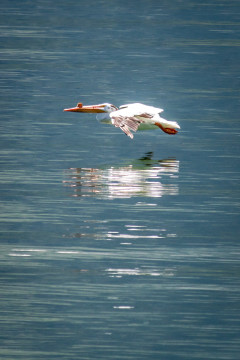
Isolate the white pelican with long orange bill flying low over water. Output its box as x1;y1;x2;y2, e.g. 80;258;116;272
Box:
64;103;180;139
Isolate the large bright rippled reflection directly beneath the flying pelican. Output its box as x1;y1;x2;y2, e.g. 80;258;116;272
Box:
64;153;179;199
